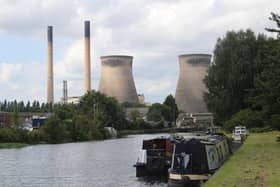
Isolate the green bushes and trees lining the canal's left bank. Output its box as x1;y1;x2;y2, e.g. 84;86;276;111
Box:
0;91;128;143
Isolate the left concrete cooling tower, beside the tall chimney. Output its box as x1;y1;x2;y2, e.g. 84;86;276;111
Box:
99;56;138;103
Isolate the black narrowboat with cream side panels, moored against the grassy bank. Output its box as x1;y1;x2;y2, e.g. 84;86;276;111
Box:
168;134;231;186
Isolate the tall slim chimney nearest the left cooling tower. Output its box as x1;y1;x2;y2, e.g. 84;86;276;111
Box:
85;21;91;93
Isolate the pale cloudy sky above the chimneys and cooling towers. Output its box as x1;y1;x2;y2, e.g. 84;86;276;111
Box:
0;0;280;102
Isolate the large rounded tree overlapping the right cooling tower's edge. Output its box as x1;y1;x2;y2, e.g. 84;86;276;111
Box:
204;30;262;123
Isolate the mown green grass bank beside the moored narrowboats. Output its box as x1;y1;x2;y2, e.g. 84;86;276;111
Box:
204;132;280;187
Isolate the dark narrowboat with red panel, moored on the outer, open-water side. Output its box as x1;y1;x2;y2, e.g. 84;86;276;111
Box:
134;136;182;177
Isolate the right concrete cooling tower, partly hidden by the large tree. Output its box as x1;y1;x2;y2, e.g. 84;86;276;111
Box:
175;54;211;113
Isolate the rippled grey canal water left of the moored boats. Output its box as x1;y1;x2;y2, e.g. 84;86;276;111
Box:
0;135;171;187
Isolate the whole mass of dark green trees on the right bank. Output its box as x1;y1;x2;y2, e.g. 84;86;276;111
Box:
204;13;280;130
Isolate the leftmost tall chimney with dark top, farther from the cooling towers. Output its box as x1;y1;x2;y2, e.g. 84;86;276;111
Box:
47;26;54;104
